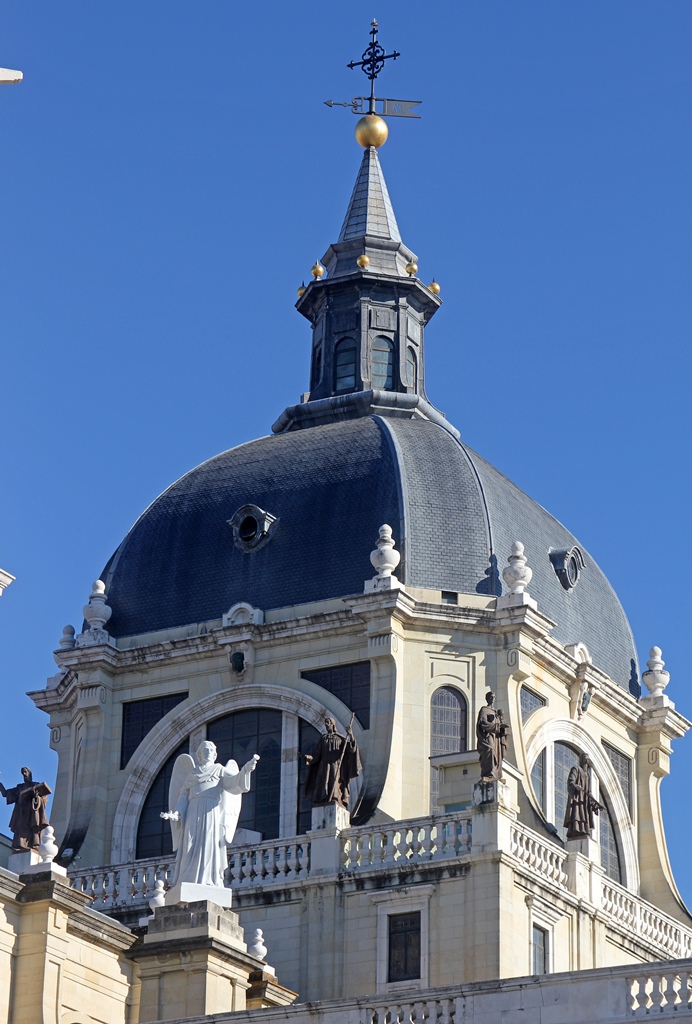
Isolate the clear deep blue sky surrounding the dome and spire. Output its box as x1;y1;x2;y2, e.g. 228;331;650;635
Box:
0;6;692;904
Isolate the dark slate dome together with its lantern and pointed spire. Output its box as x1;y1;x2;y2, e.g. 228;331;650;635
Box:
97;145;638;691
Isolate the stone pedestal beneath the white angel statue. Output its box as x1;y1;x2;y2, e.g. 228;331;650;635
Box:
131;901;278;1024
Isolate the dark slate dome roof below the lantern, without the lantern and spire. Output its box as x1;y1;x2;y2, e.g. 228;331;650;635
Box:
102;414;638;689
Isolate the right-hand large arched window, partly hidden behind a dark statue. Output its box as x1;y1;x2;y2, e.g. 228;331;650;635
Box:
531;742;622;882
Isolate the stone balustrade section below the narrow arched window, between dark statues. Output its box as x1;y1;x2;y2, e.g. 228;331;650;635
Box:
341;814;471;871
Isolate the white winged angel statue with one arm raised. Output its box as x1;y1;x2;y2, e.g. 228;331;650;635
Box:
161;739;259;890
